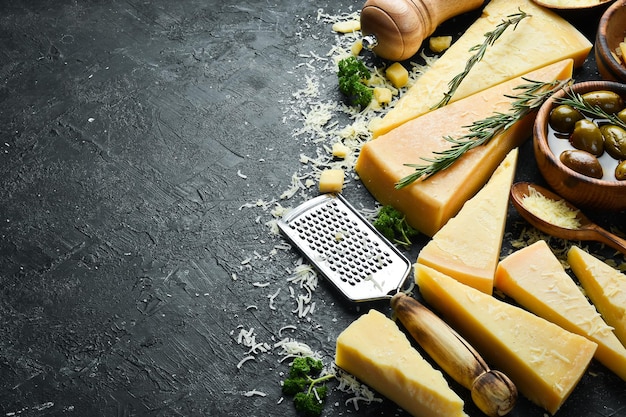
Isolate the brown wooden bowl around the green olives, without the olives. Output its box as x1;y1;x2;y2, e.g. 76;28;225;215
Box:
533;81;626;211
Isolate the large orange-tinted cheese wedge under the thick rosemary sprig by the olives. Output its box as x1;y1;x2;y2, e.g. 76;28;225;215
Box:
355;60;573;236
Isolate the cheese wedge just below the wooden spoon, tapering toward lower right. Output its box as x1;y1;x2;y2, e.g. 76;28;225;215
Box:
496;240;626;380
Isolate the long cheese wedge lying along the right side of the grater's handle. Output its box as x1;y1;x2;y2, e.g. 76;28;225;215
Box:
415;264;597;414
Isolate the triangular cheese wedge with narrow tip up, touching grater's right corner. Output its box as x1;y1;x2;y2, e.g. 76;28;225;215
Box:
417;148;518;294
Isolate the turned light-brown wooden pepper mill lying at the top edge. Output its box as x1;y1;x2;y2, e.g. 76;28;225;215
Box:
361;0;483;61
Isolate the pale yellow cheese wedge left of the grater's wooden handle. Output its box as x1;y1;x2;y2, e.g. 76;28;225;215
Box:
335;310;466;417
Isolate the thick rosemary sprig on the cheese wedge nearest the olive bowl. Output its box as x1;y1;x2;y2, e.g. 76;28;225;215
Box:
396;78;572;189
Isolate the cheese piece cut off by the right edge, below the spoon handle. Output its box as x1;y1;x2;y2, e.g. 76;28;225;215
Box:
567;246;626;346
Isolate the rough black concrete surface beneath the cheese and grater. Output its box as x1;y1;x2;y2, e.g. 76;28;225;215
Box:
0;0;626;417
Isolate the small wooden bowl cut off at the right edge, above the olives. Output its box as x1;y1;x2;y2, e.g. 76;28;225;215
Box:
594;0;626;81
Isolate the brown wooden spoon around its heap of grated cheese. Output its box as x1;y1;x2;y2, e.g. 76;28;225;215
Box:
511;182;626;254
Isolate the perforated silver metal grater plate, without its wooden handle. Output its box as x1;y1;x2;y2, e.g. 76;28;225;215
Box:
278;194;411;302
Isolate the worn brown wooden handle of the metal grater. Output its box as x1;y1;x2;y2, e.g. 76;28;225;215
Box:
391;292;517;417
